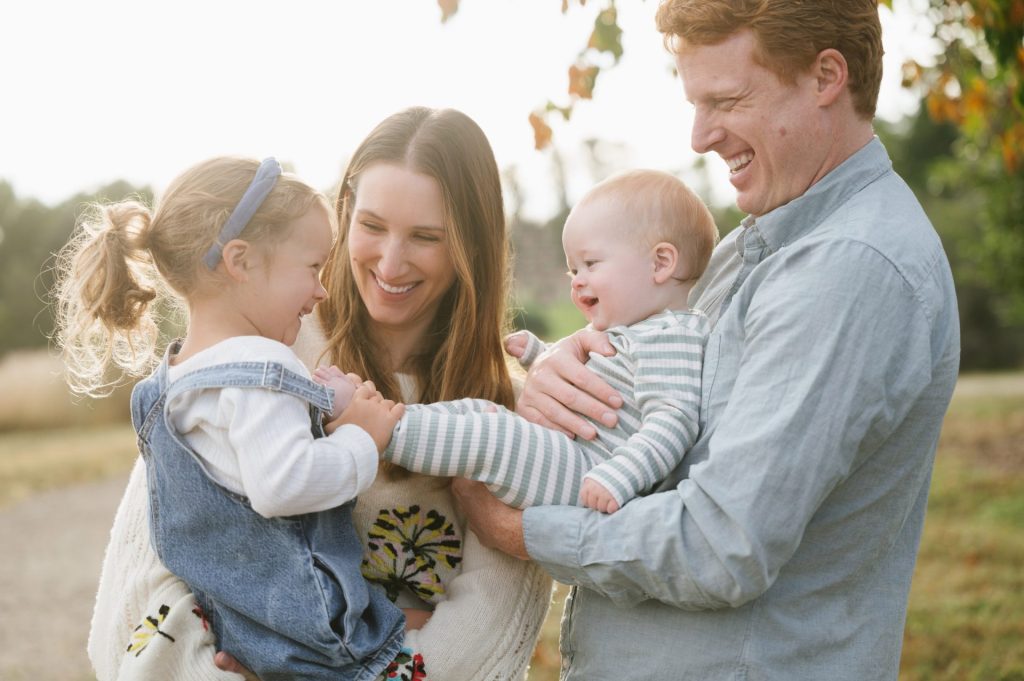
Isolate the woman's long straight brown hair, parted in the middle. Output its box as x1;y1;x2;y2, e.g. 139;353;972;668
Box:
317;107;514;408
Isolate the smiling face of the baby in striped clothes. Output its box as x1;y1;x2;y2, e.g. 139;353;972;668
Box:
562;199;658;331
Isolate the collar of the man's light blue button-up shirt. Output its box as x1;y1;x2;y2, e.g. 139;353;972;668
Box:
736;137;892;257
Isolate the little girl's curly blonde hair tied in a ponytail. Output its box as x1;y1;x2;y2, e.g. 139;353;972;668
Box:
54;157;330;396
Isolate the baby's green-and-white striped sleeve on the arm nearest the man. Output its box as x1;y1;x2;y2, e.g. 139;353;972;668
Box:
584;323;706;506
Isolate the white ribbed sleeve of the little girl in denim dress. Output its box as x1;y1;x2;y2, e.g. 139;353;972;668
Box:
220;388;378;517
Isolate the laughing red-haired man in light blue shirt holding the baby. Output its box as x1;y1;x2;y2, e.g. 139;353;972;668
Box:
458;0;959;681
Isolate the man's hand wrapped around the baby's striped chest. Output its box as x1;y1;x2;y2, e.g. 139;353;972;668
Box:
516;329;623;439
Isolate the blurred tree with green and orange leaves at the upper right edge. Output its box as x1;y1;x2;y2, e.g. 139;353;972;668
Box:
882;0;1024;326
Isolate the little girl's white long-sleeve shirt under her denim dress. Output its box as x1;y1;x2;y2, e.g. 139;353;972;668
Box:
168;336;378;517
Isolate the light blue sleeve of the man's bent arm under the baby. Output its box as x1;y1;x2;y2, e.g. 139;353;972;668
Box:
523;237;934;609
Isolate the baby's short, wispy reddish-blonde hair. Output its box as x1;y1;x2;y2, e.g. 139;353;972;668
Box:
578;169;718;283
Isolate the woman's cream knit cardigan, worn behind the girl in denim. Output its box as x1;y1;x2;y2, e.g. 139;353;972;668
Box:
88;317;551;681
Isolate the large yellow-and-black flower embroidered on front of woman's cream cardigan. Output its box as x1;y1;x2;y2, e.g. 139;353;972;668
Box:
362;505;462;603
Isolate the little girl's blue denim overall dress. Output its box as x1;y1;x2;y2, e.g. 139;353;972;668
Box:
131;344;404;681
